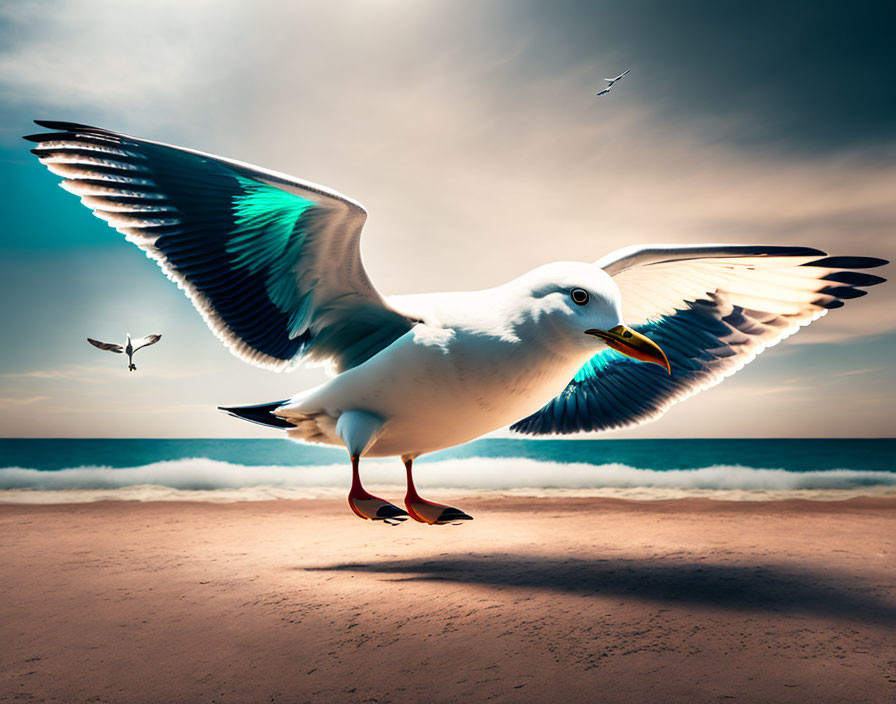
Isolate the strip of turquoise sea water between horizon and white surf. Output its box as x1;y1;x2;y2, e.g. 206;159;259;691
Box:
0;438;896;472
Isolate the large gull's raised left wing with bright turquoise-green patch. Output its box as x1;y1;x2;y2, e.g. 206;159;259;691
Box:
26;121;413;370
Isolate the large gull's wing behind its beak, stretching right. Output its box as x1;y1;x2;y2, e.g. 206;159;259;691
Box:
511;245;887;435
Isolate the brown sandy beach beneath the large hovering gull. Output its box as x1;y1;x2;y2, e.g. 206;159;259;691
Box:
0;495;896;704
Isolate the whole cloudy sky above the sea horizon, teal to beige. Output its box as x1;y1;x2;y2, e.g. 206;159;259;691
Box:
0;0;896;438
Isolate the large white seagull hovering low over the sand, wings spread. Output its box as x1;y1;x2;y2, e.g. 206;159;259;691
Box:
26;121;887;525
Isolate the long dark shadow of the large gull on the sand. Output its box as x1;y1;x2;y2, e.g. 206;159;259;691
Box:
304;553;896;625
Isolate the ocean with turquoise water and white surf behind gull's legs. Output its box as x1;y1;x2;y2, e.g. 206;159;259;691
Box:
0;439;896;498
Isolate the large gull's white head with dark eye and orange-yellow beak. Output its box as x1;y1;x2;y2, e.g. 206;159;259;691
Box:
508;262;669;371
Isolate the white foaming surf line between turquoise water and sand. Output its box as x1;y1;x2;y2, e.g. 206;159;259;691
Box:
0;458;896;501
